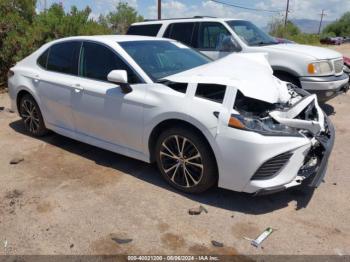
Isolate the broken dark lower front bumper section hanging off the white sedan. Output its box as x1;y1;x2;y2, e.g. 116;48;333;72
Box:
255;116;335;195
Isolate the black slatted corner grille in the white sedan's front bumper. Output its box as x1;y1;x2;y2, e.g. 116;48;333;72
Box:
251;152;293;180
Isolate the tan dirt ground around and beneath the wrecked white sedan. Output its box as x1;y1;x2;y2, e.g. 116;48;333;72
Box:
0;47;350;255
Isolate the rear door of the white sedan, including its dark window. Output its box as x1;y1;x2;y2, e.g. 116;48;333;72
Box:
34;41;81;134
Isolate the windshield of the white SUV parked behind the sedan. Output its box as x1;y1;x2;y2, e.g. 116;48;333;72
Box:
227;20;278;46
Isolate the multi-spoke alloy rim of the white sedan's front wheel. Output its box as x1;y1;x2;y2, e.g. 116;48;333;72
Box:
160;135;203;188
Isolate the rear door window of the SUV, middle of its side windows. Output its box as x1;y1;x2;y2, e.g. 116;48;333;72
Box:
164;23;195;46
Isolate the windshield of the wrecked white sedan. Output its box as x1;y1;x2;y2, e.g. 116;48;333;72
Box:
119;41;211;81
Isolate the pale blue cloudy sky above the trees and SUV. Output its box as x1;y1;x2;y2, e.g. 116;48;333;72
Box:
37;0;350;27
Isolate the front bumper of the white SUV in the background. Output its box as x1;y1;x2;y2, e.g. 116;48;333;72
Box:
299;73;349;102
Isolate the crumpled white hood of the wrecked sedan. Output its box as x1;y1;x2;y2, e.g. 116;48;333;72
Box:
164;53;290;103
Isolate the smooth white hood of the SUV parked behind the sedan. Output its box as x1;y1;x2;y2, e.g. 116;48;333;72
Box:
261;44;342;60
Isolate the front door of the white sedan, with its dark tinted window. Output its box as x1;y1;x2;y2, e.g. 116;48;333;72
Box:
73;42;146;152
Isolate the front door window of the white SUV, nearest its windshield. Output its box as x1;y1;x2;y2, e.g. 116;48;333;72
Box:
198;22;231;50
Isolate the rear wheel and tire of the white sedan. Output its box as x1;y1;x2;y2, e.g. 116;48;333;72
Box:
19;94;48;137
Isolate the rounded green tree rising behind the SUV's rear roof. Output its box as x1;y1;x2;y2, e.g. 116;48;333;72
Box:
107;2;143;34
